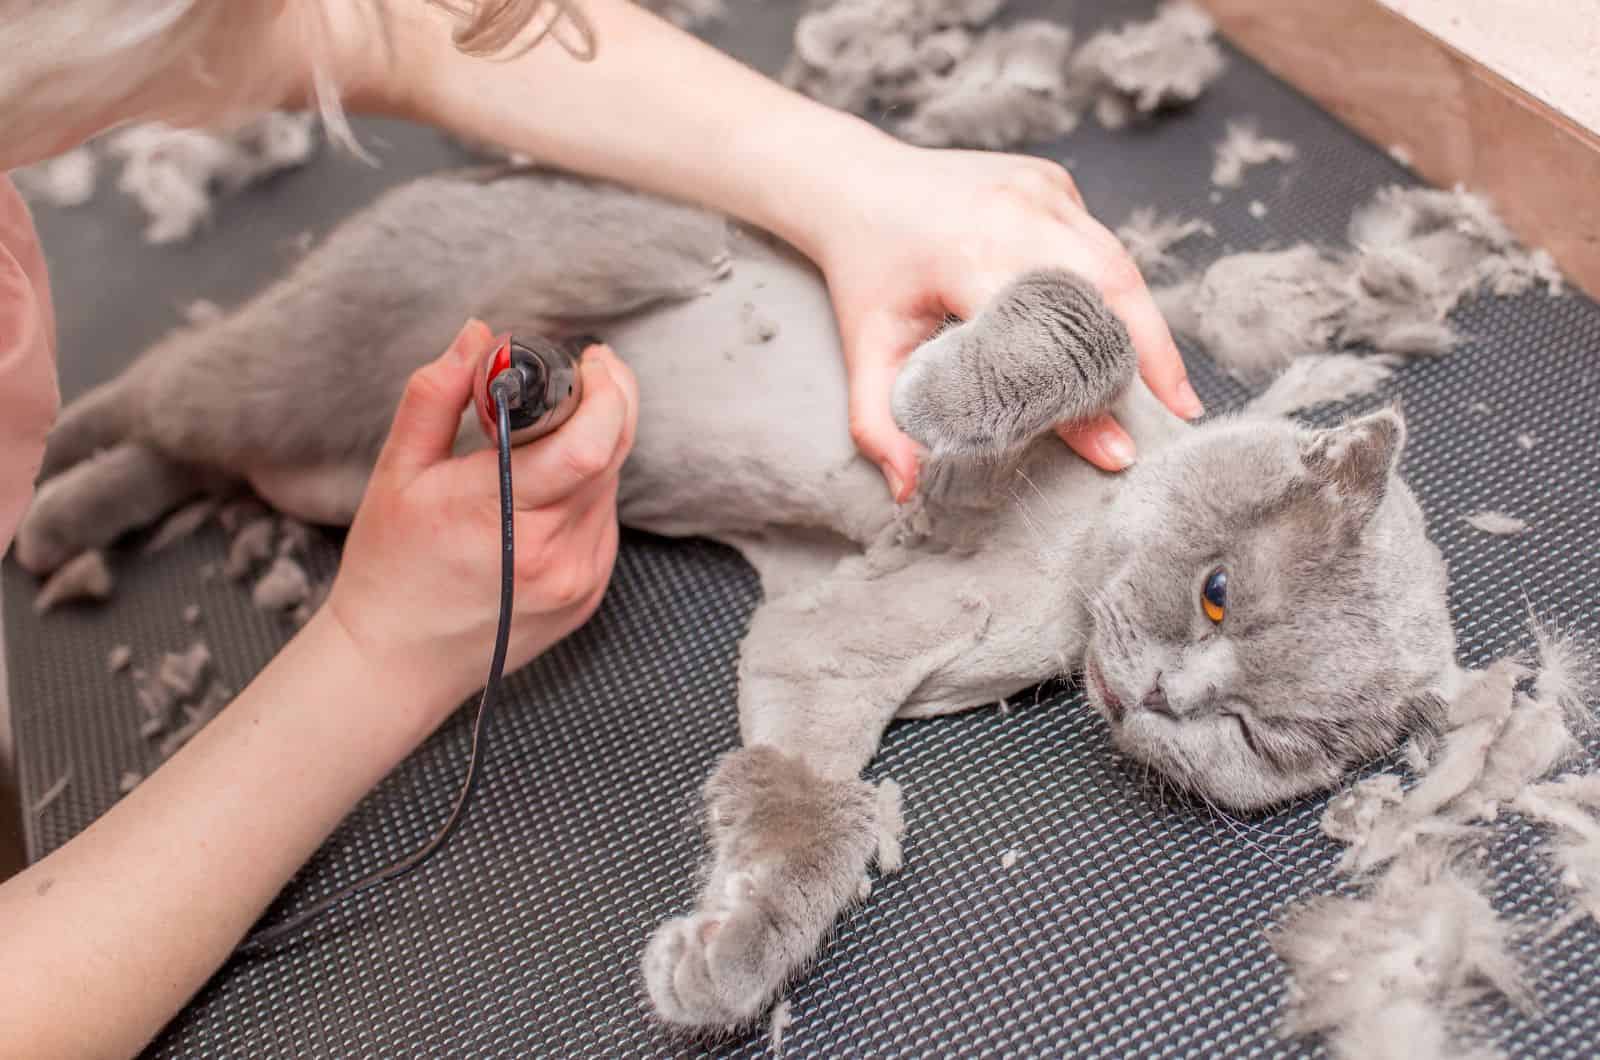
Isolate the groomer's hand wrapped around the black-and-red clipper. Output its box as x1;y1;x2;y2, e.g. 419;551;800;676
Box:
326;320;638;732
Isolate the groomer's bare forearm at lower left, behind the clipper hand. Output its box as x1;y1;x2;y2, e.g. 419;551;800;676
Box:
0;613;441;1057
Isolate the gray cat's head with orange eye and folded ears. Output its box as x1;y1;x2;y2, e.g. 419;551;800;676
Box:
1085;410;1454;810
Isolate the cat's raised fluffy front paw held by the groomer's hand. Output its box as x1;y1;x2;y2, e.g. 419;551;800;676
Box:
893;269;1138;456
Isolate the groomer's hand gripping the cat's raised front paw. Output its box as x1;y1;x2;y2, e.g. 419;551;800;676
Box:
805;143;1203;501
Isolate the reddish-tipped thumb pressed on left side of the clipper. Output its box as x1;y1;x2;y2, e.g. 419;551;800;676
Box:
376;320;494;476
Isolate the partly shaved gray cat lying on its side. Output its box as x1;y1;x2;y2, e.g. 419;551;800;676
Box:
18;171;1458;1030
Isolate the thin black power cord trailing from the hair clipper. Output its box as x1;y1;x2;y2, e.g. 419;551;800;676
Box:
235;390;522;954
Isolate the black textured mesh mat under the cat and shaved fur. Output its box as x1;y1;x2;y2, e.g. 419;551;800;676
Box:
5;0;1600;1057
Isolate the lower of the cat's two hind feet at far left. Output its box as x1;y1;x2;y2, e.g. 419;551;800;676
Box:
16;442;221;575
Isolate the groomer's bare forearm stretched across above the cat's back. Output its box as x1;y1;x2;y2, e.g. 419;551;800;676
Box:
352;0;894;259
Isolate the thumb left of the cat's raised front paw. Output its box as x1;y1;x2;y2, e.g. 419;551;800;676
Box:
845;314;923;503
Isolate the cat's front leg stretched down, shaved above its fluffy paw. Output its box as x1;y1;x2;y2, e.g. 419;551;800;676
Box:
643;557;989;1031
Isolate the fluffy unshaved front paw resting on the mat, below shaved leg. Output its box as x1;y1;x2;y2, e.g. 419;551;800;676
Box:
642;746;898;1031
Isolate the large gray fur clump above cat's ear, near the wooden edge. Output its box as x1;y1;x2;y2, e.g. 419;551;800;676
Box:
1157;187;1560;383
